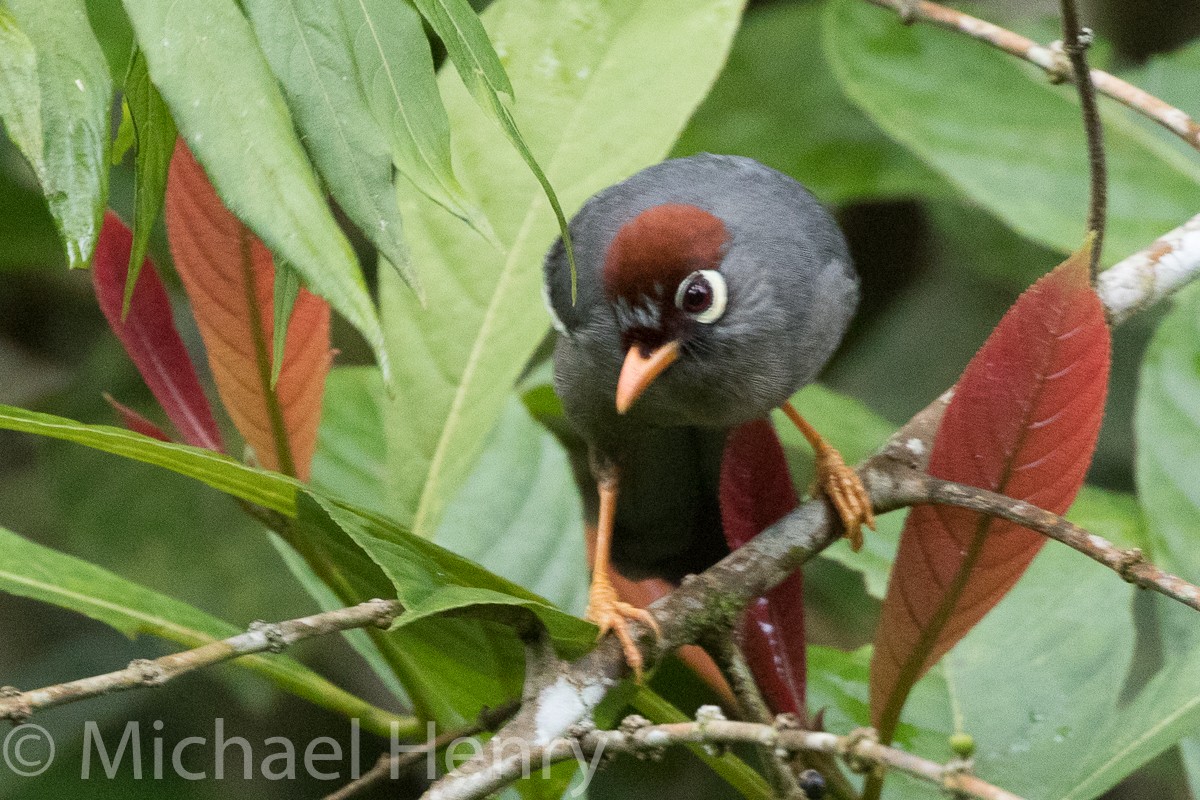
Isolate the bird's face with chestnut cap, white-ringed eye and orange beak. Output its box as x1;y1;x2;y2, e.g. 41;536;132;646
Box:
602;203;730;414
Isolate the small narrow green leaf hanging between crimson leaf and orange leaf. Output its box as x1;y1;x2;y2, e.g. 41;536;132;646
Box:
121;50;175;319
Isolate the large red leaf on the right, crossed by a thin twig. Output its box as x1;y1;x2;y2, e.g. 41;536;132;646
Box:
871;247;1110;742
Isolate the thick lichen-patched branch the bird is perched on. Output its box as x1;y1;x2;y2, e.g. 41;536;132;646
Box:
424;201;1200;800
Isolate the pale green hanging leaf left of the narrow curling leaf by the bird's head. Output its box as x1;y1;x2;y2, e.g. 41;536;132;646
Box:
338;0;498;243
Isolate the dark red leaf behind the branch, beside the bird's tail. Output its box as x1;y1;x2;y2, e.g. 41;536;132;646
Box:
721;420;806;718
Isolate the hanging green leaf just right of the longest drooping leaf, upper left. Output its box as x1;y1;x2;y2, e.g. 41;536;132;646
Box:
245;0;420;297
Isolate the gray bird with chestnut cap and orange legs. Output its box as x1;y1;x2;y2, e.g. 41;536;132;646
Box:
545;155;874;674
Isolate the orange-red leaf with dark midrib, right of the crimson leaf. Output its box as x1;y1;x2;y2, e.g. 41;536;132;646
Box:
166;140;331;480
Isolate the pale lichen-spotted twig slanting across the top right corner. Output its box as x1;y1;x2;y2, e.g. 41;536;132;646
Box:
866;0;1200;150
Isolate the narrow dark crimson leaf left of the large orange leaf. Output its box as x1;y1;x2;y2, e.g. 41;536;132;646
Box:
91;211;224;451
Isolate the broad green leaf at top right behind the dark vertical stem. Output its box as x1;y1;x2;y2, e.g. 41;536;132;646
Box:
824;0;1200;261
